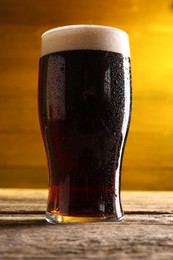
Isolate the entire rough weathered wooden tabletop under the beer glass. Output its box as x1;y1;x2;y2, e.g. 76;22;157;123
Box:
0;189;173;260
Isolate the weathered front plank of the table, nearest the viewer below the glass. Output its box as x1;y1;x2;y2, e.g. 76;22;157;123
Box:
0;220;173;260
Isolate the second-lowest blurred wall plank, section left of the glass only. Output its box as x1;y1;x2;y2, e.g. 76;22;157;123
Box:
0;132;46;167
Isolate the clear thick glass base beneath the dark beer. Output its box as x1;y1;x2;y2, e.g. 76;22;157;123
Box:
46;212;124;224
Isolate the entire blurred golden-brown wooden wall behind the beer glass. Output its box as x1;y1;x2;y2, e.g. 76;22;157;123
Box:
0;0;173;190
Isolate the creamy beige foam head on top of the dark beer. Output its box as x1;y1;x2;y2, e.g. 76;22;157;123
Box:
41;25;130;57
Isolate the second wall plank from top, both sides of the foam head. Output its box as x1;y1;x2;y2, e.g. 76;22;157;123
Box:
0;23;173;97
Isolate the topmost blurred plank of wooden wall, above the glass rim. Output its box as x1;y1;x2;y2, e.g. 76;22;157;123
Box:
0;0;172;26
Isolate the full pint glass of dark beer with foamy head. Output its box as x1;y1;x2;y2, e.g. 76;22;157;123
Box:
38;25;131;224
